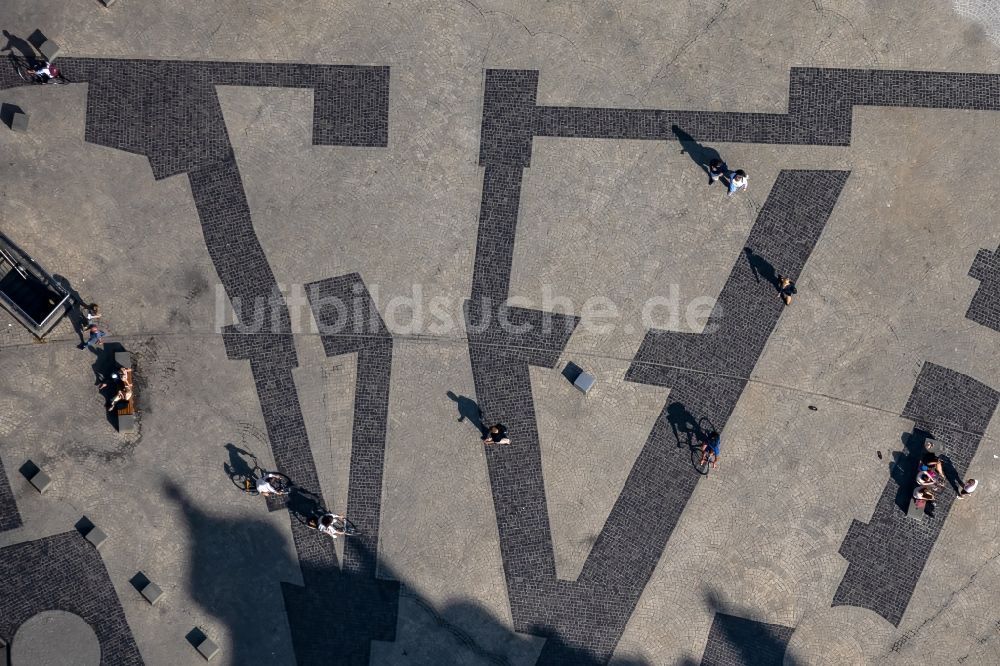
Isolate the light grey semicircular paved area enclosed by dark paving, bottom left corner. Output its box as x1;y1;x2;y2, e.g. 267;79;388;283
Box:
10;611;101;666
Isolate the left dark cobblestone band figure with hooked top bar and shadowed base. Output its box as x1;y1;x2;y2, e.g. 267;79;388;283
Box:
60;58;399;664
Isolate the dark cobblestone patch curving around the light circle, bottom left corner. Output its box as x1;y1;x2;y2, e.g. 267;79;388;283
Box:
0;532;143;666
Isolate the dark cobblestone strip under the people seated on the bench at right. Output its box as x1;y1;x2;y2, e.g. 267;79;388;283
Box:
833;363;1000;626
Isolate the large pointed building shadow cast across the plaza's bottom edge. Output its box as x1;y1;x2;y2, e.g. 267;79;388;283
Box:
164;481;668;666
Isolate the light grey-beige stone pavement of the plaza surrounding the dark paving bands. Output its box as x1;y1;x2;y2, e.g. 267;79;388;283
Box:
0;0;1000;665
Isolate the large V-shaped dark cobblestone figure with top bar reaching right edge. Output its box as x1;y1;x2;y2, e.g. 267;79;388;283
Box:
466;63;1000;664
